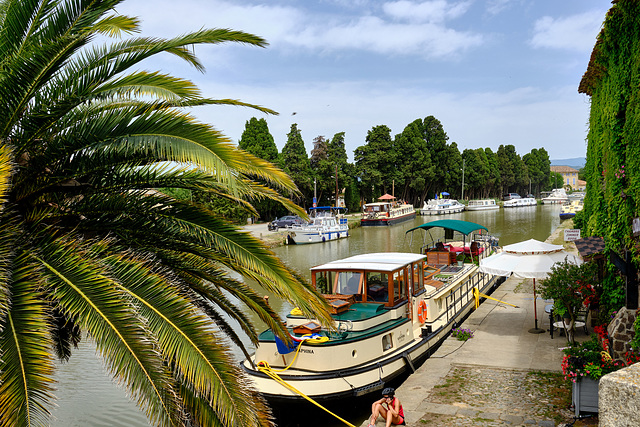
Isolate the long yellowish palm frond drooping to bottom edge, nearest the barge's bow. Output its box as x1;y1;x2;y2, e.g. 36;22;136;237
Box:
105;252;268;426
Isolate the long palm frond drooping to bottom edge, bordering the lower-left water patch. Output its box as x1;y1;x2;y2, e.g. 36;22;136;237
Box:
34;239;178;425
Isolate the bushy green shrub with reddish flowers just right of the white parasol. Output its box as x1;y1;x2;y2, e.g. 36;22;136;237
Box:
540;262;597;344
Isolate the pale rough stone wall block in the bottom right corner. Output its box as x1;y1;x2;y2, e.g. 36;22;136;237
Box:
598;363;640;427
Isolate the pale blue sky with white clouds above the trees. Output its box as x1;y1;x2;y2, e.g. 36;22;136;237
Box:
116;0;611;161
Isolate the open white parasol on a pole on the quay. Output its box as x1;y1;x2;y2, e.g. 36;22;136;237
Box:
480;239;582;333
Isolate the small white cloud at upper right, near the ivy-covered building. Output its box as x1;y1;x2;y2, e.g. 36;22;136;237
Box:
530;10;603;52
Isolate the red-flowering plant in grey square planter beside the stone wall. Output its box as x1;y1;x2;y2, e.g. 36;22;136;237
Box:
562;332;625;416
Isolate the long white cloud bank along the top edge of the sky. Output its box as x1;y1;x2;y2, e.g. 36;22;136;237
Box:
121;0;484;58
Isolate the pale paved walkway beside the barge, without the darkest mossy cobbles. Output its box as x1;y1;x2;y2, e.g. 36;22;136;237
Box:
363;278;587;427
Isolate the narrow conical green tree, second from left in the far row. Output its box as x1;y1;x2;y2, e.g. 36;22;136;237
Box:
280;123;313;207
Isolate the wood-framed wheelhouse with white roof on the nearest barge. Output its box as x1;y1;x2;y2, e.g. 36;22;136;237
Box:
311;253;424;307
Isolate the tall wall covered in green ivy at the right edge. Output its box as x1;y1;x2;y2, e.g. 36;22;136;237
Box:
579;0;640;262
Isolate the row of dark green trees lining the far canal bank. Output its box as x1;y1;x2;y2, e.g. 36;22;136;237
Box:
239;116;562;219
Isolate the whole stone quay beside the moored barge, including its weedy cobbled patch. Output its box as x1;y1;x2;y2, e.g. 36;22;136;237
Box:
362;222;597;427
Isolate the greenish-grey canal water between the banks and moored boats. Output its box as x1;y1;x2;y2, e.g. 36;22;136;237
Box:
51;205;560;427
